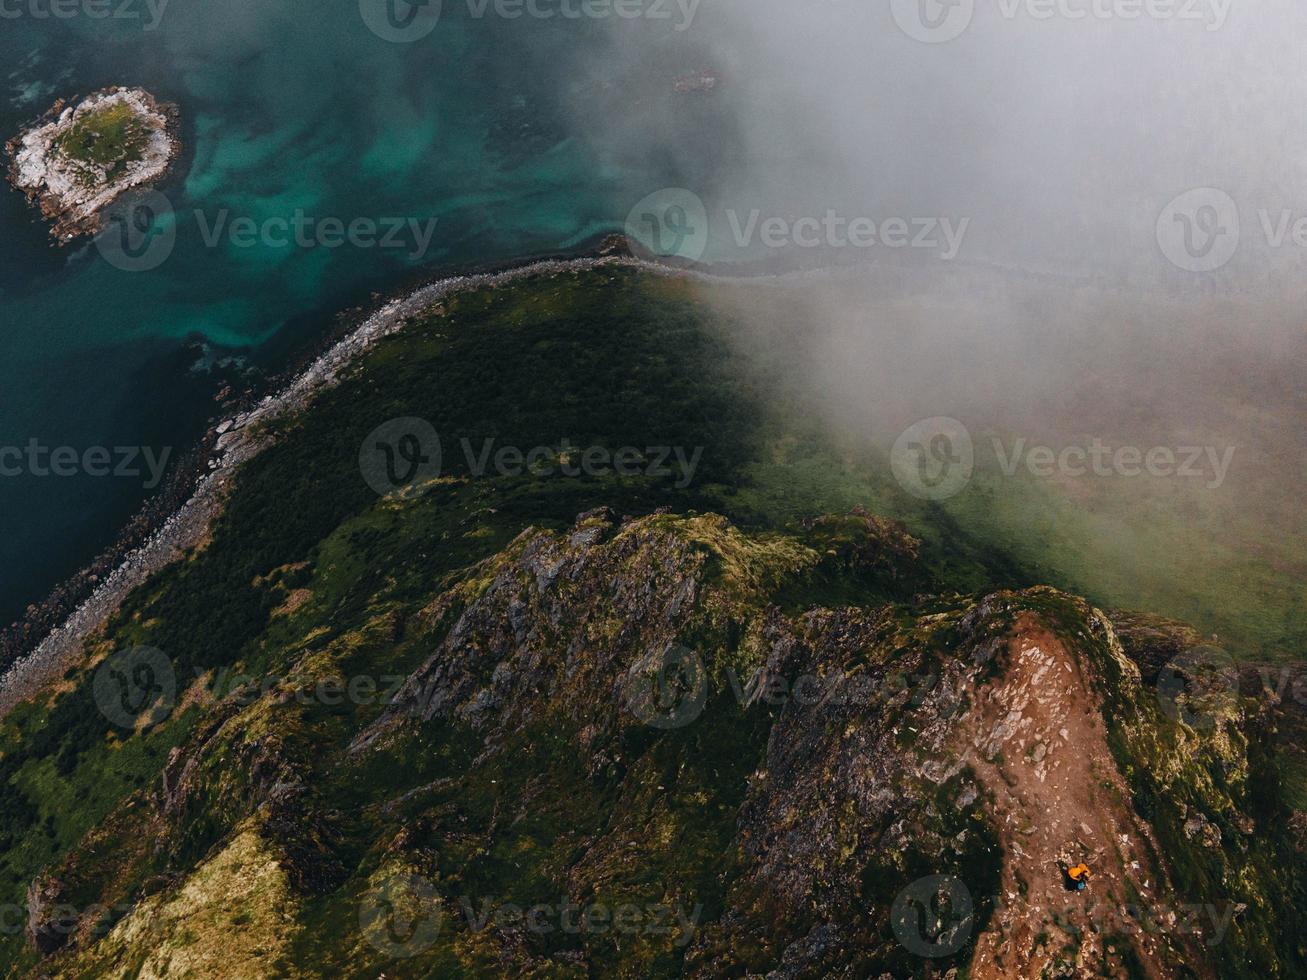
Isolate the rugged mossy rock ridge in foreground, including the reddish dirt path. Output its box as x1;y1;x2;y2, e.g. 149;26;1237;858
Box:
7;508;1296;979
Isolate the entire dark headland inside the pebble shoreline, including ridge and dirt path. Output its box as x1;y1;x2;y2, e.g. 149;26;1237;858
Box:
0;265;1304;977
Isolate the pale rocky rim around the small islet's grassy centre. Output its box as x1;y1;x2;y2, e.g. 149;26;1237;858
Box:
5;86;182;244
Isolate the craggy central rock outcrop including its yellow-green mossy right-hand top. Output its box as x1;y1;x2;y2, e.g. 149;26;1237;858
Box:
354;508;819;751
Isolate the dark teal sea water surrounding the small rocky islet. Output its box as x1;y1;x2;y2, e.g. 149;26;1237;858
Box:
0;0;724;623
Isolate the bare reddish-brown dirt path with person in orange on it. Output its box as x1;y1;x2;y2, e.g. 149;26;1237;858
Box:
961;614;1191;980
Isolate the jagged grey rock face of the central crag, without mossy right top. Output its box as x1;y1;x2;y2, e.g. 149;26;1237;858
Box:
358;508;707;746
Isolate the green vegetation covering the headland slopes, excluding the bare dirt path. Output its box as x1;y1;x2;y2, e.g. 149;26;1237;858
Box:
0;269;1302;977
